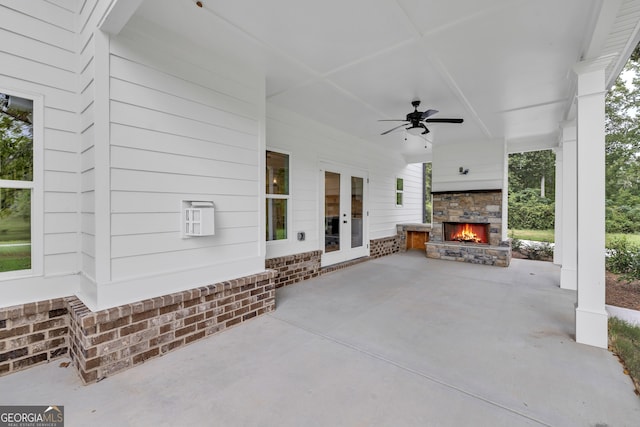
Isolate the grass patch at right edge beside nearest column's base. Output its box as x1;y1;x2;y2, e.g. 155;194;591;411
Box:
609;317;640;393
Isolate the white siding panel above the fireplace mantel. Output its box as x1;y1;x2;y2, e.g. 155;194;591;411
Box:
432;140;506;192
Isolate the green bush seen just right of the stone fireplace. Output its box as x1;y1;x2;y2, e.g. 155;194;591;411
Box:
509;188;555;230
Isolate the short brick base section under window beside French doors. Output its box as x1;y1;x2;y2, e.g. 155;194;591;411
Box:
265;251;322;288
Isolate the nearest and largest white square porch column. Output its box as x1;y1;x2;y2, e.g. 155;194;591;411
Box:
574;58;610;348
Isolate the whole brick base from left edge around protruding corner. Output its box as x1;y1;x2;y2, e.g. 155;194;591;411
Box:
0;270;276;384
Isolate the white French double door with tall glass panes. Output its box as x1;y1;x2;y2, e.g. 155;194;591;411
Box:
321;164;369;266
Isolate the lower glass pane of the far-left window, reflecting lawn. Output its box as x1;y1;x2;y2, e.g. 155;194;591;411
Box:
0;188;31;272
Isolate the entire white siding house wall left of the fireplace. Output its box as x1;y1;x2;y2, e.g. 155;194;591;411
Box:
0;0;422;310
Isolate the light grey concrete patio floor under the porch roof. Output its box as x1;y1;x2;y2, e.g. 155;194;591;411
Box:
0;252;640;426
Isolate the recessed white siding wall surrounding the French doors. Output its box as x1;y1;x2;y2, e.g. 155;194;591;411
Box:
267;104;423;258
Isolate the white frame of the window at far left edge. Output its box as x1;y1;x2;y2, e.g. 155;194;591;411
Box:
0;87;44;281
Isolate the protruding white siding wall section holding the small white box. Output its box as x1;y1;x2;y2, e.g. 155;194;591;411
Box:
82;18;265;308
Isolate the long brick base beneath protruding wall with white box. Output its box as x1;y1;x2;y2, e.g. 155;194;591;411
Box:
69;271;275;383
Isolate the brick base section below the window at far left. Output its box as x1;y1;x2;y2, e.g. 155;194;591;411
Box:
0;298;69;375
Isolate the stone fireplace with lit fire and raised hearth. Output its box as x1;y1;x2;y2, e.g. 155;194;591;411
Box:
426;190;511;267
